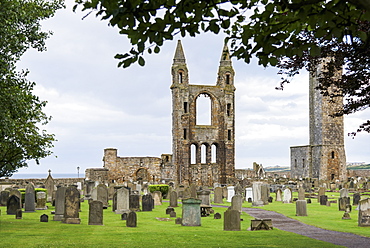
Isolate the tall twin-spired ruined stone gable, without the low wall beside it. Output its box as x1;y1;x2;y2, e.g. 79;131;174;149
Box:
171;41;235;185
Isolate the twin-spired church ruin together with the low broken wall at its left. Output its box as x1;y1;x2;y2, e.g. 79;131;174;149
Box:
103;41;235;186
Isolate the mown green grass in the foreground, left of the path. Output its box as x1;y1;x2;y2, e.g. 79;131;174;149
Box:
0;201;338;247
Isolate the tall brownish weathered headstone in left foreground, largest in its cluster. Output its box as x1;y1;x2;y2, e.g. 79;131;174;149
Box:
62;186;81;224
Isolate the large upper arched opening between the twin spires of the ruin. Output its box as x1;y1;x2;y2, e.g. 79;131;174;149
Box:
196;93;212;125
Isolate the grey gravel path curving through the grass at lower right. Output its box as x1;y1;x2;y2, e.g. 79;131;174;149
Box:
242;208;370;248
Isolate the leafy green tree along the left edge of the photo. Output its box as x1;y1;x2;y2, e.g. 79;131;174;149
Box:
0;0;63;177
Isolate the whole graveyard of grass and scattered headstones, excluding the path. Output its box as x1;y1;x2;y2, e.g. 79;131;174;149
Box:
0;183;370;247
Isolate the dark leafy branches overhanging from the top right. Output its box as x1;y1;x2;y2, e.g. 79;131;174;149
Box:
74;0;370;132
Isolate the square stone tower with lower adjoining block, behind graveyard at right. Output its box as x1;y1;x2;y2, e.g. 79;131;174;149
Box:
290;59;346;180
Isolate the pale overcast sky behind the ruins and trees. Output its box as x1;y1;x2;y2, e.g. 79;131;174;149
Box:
10;0;370;178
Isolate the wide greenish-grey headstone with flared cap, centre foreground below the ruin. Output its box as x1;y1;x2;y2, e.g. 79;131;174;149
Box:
181;198;201;226
